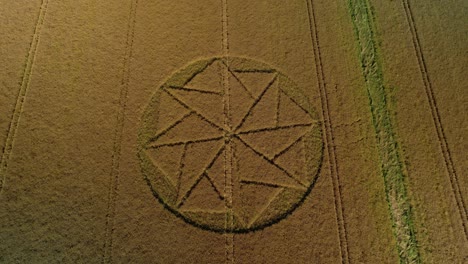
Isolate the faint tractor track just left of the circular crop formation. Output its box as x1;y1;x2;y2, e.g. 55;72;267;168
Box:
101;0;138;263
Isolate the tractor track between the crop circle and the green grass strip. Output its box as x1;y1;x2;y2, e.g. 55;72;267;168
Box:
306;0;350;263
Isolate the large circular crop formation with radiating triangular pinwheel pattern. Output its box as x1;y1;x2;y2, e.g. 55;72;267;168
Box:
139;57;323;232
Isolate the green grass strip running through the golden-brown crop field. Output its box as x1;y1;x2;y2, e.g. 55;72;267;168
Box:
348;0;421;263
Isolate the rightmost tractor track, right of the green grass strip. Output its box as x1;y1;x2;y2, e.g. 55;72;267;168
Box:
401;0;468;240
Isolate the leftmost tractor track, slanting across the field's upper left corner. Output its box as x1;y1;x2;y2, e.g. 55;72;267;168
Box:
0;0;49;195
